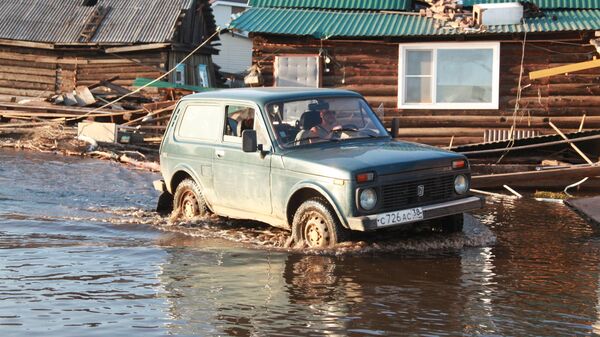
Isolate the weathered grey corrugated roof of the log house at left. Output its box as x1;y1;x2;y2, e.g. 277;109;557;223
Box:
0;0;193;44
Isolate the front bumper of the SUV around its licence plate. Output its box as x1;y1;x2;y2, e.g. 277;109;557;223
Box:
347;196;485;232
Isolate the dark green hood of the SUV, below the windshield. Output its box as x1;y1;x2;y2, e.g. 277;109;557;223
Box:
282;140;465;179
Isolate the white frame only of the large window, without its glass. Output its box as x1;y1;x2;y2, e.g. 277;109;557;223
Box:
398;41;500;110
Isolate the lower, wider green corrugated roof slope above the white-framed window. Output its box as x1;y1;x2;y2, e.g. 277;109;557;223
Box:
230;8;600;39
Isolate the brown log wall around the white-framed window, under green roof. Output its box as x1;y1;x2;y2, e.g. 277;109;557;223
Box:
253;35;600;145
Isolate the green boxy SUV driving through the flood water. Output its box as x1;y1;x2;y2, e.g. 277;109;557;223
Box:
155;88;483;247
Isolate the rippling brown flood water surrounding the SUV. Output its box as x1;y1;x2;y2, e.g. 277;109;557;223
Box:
0;150;600;337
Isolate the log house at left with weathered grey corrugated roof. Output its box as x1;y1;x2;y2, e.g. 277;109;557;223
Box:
0;0;218;101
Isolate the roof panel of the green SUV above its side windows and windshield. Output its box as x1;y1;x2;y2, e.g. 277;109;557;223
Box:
183;87;362;105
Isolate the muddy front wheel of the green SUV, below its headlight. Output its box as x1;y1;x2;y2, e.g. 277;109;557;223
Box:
292;199;349;248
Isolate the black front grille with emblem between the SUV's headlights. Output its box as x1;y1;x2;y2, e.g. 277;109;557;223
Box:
380;175;454;211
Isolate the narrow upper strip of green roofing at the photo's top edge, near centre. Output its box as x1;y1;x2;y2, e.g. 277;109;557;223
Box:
250;0;412;11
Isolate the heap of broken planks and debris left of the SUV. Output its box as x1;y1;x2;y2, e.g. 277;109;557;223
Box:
0;77;191;170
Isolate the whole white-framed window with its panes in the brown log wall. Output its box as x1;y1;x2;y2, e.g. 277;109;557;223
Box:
398;42;500;109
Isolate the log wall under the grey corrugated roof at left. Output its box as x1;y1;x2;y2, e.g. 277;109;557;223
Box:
0;46;168;101
